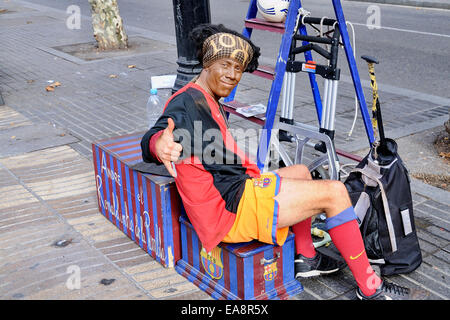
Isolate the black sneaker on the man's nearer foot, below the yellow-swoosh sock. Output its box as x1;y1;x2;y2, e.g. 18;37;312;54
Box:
356;280;429;300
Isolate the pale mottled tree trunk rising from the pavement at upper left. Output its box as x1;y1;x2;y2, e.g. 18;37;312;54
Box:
89;0;128;50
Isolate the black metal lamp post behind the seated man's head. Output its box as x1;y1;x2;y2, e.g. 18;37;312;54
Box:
172;0;211;93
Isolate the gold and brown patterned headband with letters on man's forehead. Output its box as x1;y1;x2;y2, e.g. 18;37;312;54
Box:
203;32;253;70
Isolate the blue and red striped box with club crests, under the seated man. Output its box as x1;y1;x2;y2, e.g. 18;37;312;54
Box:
175;216;303;300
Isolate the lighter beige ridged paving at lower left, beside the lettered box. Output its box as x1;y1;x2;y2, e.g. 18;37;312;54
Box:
0;146;209;299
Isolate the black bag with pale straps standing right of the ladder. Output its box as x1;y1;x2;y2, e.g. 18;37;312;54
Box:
344;139;422;276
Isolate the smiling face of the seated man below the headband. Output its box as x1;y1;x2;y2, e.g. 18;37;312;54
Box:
205;58;244;99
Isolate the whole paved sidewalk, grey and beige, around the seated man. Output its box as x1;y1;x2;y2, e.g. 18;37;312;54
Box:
0;0;450;300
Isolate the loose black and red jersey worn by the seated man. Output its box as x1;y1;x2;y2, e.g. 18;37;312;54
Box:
141;82;260;252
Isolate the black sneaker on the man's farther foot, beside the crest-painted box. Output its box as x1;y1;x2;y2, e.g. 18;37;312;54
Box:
294;251;345;278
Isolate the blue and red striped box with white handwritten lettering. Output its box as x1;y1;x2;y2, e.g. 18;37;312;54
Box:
92;133;182;267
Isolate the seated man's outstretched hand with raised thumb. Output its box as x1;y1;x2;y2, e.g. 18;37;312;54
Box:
155;118;183;178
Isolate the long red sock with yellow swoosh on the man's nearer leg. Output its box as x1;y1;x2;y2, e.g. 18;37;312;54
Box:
328;220;381;296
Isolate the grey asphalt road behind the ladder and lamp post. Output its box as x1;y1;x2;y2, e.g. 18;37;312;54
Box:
20;0;450;98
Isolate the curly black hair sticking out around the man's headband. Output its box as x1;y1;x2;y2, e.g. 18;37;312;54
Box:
189;23;261;72
